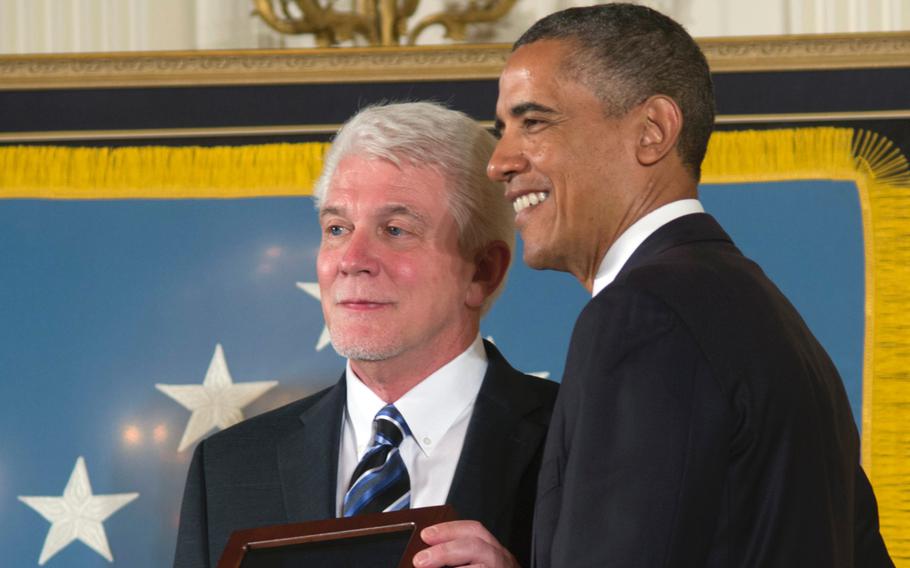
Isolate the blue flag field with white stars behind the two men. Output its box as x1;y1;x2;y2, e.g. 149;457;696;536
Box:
0;182;863;568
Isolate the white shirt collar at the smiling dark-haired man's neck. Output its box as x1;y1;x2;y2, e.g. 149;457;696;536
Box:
591;199;705;296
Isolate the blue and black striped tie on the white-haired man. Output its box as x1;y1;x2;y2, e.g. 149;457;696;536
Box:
343;404;411;517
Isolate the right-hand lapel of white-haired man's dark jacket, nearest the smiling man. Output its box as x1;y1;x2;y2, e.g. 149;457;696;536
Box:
446;342;546;533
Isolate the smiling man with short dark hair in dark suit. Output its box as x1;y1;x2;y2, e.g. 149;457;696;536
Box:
488;4;892;568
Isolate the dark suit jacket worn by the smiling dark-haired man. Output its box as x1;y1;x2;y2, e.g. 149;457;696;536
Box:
534;214;892;568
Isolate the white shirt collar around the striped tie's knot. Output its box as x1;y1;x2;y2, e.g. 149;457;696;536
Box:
345;333;487;455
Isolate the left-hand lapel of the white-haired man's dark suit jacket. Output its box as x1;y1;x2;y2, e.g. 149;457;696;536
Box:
278;375;345;522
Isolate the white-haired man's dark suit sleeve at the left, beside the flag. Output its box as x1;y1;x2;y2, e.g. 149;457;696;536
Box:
174;442;209;568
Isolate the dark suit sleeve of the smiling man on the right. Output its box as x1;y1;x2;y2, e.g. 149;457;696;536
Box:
541;293;735;567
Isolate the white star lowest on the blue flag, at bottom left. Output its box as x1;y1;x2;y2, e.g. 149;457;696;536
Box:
19;456;139;566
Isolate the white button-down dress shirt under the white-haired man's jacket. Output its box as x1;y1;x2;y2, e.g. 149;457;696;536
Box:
335;334;487;516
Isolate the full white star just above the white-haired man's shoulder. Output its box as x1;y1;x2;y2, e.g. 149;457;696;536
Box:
155;343;278;452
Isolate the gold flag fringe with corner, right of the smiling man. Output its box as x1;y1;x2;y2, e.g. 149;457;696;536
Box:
702;127;910;566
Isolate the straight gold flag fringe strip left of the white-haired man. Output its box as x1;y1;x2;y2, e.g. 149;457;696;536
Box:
0;142;328;199
